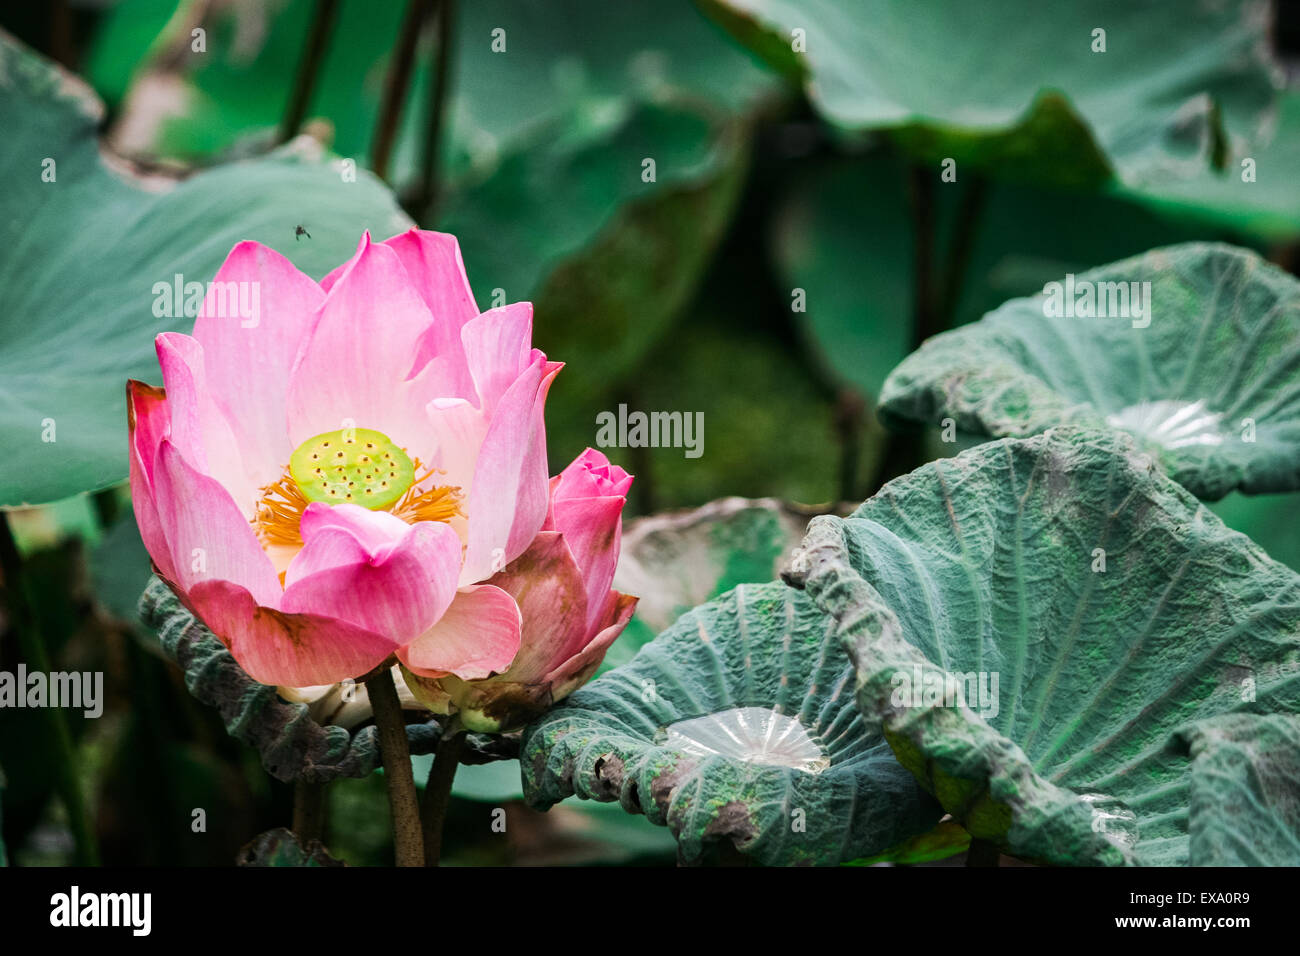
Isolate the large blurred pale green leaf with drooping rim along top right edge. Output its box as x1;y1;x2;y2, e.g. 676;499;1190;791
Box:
703;0;1281;185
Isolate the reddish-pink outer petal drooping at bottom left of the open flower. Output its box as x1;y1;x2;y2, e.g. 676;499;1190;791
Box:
189;580;395;687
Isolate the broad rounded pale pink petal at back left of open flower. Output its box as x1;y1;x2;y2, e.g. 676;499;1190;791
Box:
194;242;325;488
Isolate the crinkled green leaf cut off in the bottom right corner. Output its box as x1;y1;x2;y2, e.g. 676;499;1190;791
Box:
1178;714;1300;866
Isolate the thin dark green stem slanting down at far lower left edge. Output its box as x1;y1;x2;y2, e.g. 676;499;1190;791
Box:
0;512;99;866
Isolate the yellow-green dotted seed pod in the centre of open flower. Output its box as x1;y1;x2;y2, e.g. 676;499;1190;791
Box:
289;428;415;511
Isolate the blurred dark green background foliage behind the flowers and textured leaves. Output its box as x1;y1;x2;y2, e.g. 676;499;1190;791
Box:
0;0;1300;865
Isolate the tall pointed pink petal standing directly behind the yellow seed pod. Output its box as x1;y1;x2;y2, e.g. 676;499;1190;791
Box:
289;241;433;458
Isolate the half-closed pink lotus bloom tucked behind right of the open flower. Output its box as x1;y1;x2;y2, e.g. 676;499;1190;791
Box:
403;449;637;732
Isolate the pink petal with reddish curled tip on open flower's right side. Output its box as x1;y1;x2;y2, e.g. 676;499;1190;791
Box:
460;349;562;584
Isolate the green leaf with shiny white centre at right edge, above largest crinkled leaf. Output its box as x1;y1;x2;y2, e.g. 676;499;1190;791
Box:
880;243;1300;501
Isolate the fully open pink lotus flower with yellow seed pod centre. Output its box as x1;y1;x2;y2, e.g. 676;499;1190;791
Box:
127;230;572;687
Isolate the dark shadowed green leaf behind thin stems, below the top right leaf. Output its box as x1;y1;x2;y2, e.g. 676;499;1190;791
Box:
772;150;1242;395
